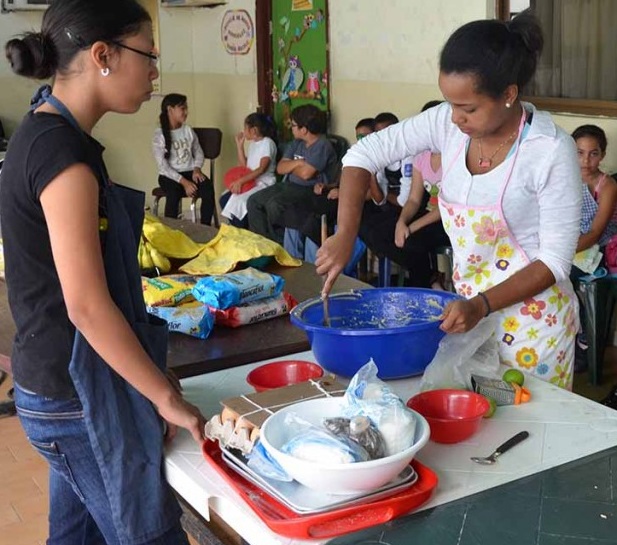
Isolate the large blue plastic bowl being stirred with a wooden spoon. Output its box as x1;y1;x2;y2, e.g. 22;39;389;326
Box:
291;288;460;379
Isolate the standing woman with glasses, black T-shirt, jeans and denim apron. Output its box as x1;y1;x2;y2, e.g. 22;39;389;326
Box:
0;0;204;545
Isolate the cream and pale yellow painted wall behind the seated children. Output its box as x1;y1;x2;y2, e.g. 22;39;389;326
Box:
0;0;617;192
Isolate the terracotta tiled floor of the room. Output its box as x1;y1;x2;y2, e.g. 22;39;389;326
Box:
0;347;617;545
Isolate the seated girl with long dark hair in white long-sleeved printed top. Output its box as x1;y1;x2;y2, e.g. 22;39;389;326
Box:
152;93;214;225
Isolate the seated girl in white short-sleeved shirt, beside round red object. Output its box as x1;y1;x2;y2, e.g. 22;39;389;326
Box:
219;113;277;229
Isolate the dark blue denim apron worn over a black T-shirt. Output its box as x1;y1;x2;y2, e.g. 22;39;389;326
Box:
42;94;181;545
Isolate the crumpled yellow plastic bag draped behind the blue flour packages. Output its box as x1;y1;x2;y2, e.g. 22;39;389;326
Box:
180;225;302;275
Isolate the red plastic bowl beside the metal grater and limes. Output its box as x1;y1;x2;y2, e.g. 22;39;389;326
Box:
407;390;490;443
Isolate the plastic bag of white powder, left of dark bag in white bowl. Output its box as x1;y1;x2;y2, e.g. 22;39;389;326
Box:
281;412;369;464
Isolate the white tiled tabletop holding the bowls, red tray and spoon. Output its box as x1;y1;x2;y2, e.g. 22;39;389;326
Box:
166;352;617;545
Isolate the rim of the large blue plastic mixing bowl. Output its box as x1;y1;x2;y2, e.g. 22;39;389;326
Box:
290;288;463;336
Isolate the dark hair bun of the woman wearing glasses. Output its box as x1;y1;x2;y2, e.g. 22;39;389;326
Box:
5;32;58;79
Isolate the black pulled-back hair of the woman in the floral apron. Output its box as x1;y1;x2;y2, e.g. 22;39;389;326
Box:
439;9;544;98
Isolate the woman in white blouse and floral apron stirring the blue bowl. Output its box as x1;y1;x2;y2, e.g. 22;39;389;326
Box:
316;11;581;388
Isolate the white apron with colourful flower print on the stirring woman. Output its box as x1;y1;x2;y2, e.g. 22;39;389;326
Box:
439;112;578;390
